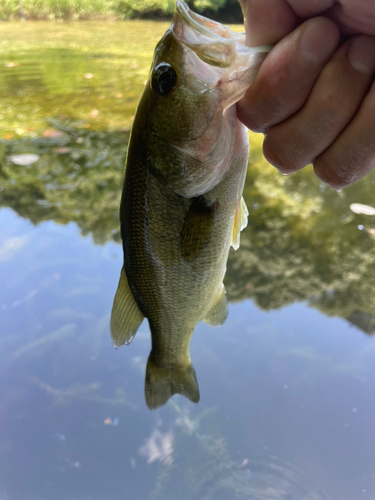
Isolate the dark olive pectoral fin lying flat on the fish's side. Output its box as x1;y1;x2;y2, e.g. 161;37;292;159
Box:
180;196;217;262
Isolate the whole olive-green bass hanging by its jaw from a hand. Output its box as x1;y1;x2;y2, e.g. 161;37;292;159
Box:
110;0;269;409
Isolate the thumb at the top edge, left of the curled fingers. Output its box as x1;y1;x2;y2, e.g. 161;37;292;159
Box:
239;0;300;46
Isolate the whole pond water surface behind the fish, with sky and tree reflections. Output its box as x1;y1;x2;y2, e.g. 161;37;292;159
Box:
0;22;375;500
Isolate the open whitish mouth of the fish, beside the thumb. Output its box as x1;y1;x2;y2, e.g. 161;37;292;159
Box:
173;0;271;68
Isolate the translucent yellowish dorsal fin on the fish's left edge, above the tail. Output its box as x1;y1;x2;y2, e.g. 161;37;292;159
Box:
111;268;144;347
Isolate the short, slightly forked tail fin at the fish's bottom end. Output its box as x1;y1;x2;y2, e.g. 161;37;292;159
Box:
145;353;200;410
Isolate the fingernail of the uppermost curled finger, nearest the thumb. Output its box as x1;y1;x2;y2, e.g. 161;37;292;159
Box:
300;18;339;64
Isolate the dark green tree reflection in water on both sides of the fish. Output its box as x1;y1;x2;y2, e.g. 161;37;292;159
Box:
0;120;375;334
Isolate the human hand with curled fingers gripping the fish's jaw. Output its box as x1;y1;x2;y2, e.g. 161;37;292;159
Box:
238;0;375;189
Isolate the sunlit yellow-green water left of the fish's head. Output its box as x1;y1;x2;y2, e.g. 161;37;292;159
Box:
0;21;167;137
